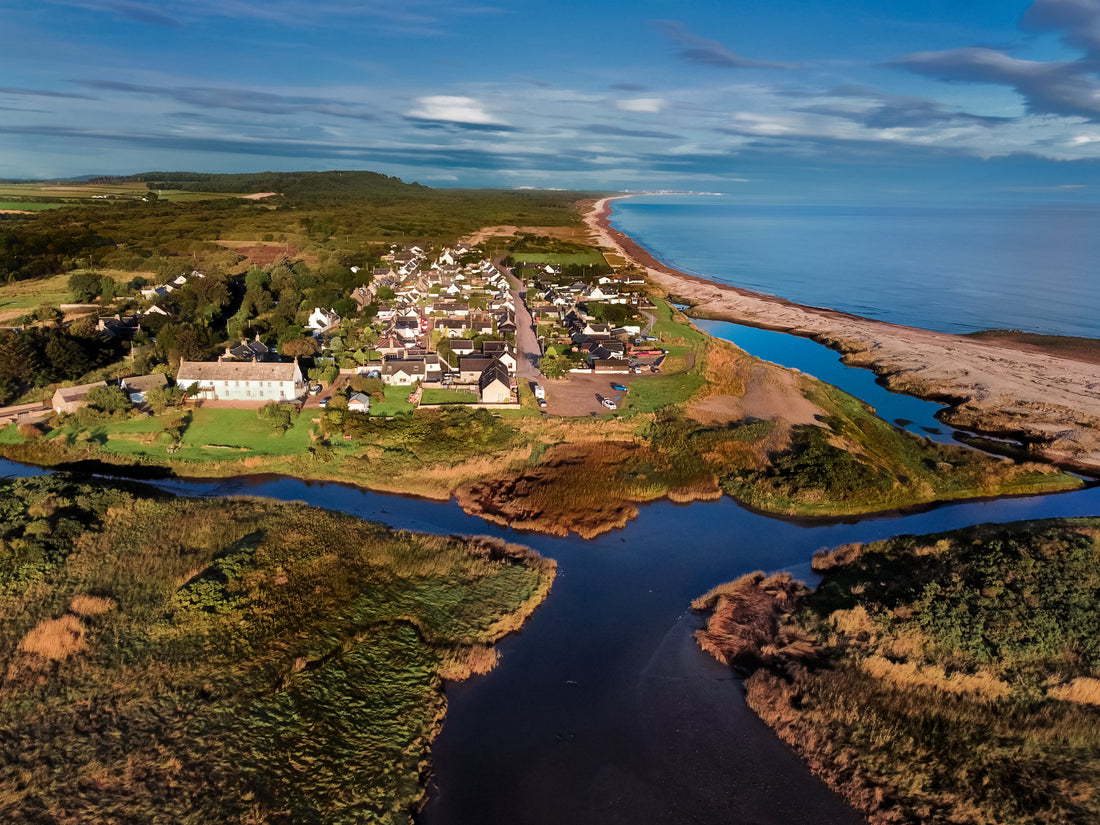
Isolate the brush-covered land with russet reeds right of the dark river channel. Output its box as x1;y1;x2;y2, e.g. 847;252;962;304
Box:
693;518;1100;825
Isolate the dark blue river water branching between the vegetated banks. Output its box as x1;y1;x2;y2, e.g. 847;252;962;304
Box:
0;328;1100;825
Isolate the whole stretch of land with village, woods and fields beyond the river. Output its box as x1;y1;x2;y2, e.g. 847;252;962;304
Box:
0;173;1081;536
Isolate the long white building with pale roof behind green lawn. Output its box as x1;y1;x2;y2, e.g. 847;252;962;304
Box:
176;361;306;402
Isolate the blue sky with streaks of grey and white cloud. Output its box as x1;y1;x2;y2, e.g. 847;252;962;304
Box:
0;0;1100;201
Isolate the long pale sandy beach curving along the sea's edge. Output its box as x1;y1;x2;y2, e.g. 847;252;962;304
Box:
585;196;1100;474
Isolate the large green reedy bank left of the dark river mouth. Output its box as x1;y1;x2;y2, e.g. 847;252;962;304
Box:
0;476;553;823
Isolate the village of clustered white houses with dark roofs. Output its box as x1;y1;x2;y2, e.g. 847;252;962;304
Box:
0;244;664;422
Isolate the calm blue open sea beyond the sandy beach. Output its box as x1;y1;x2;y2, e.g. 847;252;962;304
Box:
612;196;1100;338
